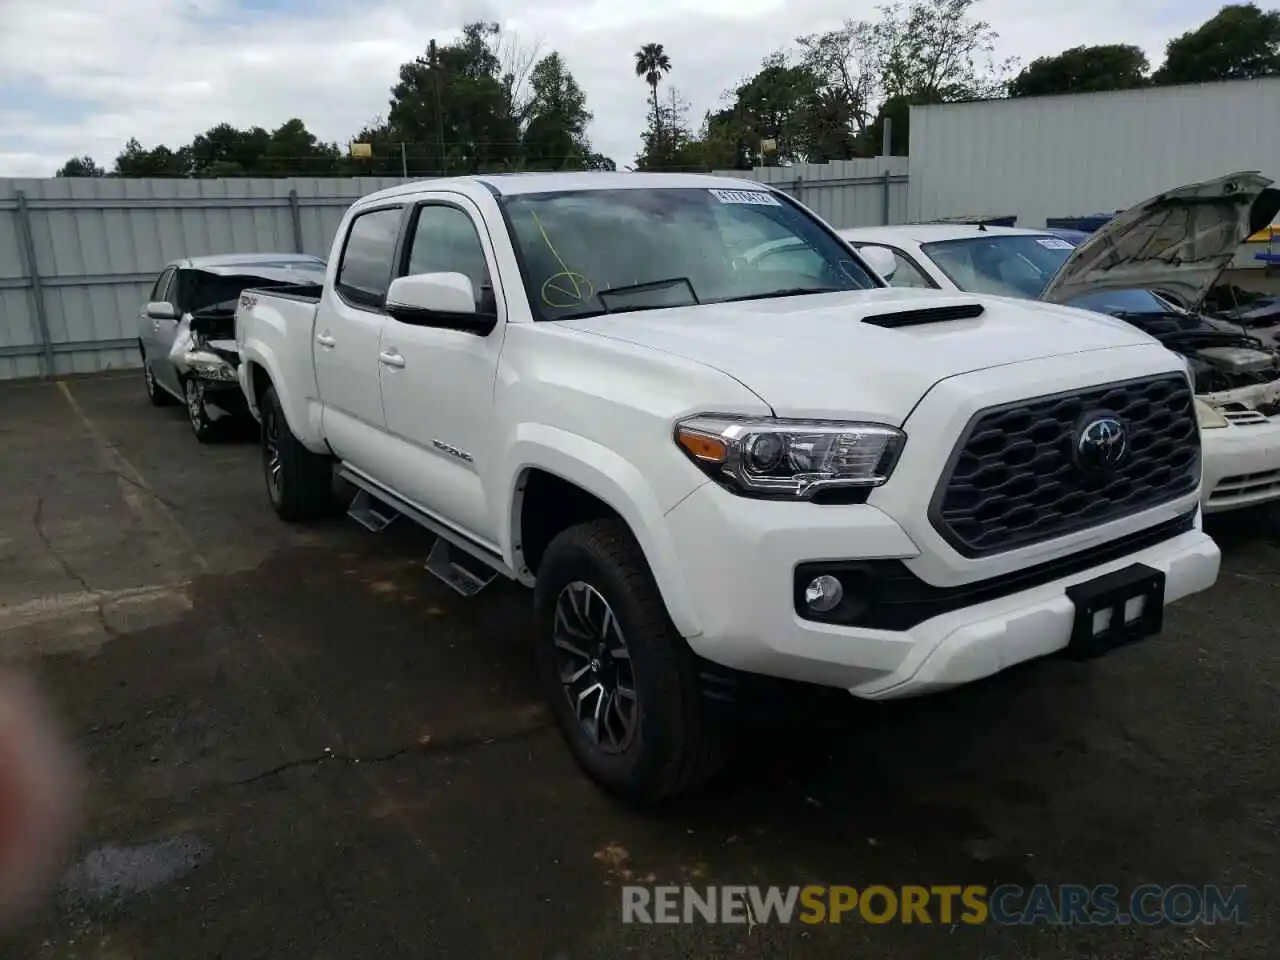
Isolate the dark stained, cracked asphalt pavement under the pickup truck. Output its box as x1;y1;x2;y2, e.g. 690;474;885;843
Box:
0;374;1280;960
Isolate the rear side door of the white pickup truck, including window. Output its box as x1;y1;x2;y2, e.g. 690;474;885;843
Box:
311;204;404;468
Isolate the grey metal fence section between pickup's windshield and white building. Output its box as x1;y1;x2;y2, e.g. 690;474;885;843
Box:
716;156;909;229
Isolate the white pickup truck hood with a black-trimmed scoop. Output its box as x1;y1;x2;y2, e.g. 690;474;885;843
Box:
557;288;1155;425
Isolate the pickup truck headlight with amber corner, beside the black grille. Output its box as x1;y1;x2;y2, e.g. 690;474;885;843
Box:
676;413;906;500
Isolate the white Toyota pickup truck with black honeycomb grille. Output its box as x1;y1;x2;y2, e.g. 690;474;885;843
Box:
236;173;1220;801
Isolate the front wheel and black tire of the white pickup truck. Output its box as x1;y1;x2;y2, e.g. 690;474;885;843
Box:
534;520;724;806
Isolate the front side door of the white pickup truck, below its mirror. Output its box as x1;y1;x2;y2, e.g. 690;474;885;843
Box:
380;195;506;549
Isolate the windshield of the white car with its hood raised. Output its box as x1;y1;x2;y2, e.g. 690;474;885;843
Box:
920;234;1074;300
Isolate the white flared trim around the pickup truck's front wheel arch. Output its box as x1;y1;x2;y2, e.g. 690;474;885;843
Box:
497;424;709;639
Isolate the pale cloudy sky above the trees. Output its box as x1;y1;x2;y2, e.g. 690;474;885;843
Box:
0;0;1228;177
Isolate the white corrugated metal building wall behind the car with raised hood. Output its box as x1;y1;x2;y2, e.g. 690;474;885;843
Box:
908;77;1280;228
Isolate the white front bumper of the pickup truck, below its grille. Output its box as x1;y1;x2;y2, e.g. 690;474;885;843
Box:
668;484;1220;699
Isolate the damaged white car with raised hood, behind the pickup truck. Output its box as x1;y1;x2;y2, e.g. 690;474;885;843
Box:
840;173;1280;512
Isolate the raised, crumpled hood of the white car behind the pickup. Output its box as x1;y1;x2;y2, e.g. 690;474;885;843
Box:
1041;172;1280;310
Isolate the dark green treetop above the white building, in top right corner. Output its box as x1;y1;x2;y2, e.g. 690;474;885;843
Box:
1152;3;1280;83
